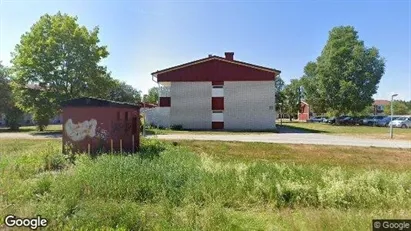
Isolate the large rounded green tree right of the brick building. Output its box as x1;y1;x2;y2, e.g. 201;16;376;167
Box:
302;26;385;116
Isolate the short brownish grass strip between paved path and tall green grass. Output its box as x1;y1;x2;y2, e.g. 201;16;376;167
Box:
172;140;411;171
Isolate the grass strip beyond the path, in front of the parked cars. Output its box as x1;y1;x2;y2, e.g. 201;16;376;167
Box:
277;122;411;140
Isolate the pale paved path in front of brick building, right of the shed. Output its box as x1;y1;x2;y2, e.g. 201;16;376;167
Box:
151;133;411;149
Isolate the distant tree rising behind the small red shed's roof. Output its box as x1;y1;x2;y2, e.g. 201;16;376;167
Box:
108;81;141;103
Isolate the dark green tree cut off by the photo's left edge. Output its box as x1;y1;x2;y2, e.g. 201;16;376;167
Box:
0;62;23;130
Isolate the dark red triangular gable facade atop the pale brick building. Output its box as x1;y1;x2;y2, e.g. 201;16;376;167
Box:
153;58;276;83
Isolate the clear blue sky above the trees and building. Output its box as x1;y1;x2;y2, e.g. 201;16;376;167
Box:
0;0;411;100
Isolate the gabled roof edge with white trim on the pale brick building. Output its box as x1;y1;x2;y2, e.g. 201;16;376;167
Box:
151;55;281;75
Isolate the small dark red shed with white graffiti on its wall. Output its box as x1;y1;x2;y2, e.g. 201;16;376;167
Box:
62;97;140;153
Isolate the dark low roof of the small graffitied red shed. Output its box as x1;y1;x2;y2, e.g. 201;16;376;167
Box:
61;97;141;109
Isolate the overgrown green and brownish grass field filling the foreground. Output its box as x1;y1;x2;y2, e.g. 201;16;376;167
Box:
0;140;411;230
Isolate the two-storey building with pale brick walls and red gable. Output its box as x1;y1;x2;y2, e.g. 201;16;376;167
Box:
148;52;281;130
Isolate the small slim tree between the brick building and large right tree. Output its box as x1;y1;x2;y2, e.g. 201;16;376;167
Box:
283;79;301;121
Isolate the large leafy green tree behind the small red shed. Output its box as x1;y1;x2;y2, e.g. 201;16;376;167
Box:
12;12;114;130
